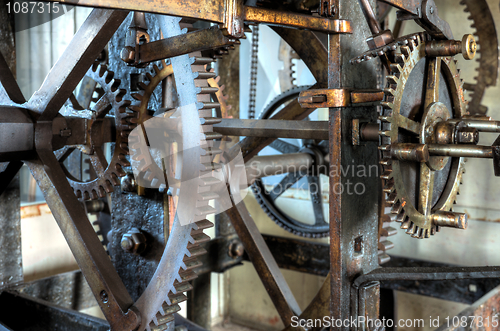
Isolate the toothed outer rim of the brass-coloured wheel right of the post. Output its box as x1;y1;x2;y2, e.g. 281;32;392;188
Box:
379;37;466;239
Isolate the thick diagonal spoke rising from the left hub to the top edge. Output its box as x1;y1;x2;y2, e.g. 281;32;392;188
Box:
27;9;128;120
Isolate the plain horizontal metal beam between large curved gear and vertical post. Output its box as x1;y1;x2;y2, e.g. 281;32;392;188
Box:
214;119;328;140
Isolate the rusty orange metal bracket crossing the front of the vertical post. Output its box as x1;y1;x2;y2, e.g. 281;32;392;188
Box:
298;88;384;108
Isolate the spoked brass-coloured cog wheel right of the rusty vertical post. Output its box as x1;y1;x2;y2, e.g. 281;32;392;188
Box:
379;38;466;239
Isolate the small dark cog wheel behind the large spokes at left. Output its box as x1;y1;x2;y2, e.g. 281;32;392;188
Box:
56;62;133;200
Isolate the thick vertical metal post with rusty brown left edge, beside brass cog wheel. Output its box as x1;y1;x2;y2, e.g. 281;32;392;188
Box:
328;0;380;331
